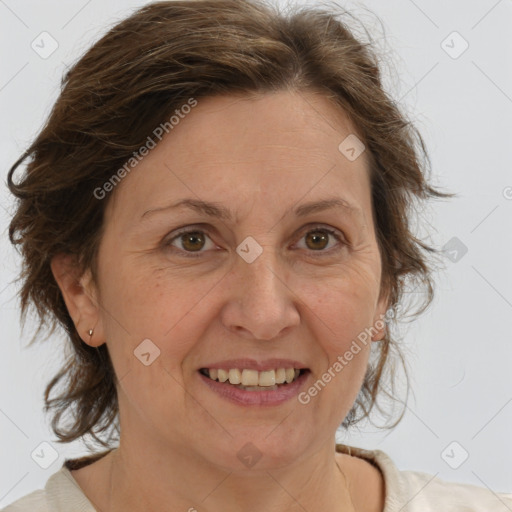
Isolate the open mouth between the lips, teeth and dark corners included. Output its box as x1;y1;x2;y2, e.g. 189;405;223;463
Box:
199;368;309;392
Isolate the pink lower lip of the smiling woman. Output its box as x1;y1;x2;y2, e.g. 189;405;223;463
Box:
198;371;309;406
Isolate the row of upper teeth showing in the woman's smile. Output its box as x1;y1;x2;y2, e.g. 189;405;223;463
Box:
204;368;300;391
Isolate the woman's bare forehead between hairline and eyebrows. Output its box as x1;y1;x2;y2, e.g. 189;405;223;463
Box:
107;91;371;227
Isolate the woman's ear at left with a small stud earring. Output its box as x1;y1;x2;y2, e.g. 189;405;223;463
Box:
51;254;105;347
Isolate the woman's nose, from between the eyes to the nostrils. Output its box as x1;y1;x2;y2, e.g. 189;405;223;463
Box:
221;249;300;340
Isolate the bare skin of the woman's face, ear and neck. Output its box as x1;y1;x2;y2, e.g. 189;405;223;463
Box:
52;91;388;511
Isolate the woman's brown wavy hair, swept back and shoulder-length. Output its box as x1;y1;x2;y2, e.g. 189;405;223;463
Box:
7;0;452;447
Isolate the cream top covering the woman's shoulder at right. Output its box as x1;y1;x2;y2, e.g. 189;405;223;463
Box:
338;445;512;512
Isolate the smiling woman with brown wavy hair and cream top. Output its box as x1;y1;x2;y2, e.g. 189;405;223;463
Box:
2;0;512;512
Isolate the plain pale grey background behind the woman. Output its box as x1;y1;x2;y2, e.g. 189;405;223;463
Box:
0;0;512;507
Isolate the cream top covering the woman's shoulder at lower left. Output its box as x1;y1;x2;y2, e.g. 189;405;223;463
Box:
0;466;95;512
